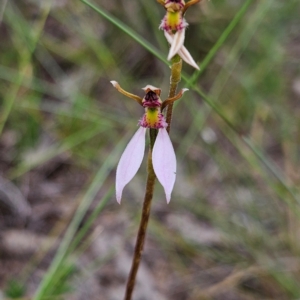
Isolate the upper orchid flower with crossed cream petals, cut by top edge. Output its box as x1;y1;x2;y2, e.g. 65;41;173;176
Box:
157;0;201;70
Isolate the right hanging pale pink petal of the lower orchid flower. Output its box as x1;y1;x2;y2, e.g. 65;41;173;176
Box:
152;128;176;203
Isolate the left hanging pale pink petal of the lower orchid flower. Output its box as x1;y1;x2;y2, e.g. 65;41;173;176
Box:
116;127;146;203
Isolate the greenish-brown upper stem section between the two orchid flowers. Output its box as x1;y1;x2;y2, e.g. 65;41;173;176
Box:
166;54;182;133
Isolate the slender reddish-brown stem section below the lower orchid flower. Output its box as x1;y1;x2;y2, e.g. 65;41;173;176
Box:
124;144;156;300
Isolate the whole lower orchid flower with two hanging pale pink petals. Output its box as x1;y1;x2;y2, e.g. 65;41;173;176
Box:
111;81;187;203
